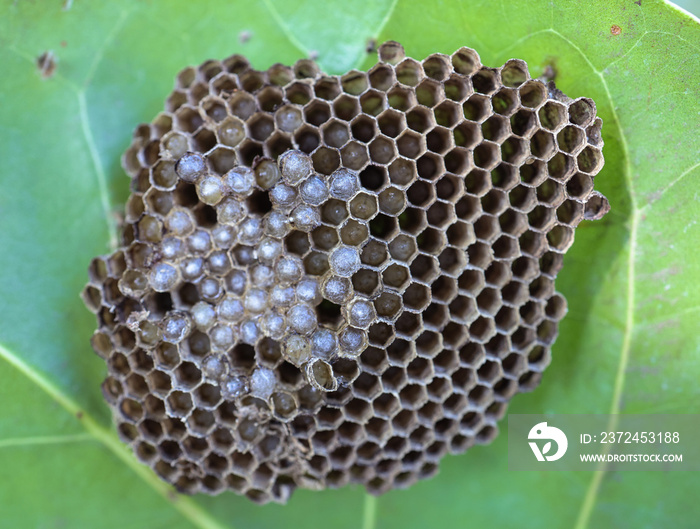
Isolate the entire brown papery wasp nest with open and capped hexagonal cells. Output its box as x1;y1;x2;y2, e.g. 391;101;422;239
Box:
84;42;609;503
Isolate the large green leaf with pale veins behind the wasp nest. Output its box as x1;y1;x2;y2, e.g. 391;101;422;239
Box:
0;0;700;529
